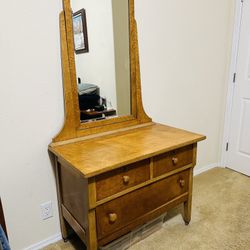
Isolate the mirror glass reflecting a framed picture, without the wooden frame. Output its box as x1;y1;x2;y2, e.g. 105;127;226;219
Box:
71;0;131;122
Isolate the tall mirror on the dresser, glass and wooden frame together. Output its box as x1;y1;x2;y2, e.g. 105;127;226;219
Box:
53;0;152;144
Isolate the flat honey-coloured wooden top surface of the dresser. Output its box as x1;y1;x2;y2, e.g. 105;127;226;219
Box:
49;124;206;178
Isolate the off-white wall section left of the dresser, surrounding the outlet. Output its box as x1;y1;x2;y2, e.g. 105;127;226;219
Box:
0;0;63;250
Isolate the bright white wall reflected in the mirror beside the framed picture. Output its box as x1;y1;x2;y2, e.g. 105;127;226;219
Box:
71;0;117;108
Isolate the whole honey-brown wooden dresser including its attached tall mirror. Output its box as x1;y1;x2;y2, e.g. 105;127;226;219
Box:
49;0;205;250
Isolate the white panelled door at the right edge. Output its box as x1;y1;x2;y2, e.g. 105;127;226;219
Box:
227;0;250;176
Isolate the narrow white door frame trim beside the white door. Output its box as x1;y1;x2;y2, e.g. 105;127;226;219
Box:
221;0;244;167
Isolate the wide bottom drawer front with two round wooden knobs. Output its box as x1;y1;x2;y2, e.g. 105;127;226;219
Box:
96;170;189;239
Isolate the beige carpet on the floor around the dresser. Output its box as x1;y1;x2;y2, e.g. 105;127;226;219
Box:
46;168;250;250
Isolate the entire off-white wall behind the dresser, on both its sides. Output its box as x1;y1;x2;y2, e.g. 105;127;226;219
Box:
0;0;233;250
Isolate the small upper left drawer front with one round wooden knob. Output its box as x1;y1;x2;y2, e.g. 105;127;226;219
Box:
96;159;150;201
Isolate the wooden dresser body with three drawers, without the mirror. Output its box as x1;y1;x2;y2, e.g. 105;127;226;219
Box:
50;124;205;250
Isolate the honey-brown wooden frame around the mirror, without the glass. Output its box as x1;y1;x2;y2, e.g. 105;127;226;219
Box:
53;0;152;143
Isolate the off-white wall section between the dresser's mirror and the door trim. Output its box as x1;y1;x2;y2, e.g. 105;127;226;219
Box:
135;0;234;169
